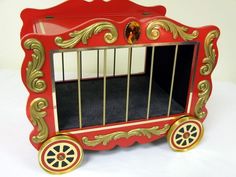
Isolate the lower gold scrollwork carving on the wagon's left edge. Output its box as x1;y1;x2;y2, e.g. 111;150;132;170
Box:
30;98;48;143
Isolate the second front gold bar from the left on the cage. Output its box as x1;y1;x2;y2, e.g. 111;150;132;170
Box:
102;49;107;125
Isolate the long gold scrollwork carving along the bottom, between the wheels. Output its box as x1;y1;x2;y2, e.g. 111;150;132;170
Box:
82;124;170;147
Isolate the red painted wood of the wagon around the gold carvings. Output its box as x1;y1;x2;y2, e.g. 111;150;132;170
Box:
21;0;219;150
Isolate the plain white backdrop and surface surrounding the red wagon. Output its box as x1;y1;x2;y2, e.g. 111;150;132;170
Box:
0;0;236;177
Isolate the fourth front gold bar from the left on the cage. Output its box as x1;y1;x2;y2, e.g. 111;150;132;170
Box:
147;46;155;119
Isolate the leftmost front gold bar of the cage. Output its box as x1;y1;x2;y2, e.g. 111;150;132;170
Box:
77;51;82;128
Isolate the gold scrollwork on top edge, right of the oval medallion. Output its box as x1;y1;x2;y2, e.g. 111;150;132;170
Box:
146;19;199;41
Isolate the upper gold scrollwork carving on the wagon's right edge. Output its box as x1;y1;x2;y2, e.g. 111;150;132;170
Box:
200;30;220;76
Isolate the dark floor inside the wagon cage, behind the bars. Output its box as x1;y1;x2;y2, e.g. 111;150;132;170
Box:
56;75;184;130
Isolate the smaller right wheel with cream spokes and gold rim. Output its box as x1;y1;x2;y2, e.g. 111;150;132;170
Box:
167;117;204;151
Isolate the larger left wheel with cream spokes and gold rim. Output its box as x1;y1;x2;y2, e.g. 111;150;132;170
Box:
39;136;84;174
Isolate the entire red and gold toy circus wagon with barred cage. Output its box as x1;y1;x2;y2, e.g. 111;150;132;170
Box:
21;0;220;174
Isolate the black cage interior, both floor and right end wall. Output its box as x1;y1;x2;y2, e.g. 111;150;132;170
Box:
55;44;195;130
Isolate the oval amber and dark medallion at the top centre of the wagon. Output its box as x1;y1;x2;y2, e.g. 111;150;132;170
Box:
125;21;141;45
